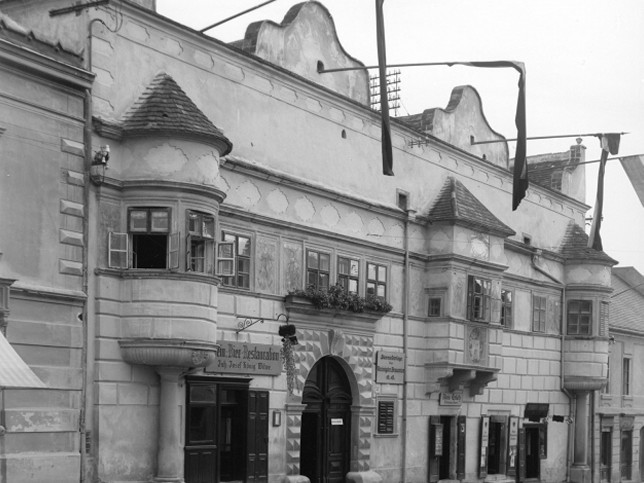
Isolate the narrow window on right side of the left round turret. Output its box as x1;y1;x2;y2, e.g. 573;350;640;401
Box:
186;211;215;274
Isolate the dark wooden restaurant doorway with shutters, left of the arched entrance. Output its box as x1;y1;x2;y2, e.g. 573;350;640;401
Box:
184;379;268;483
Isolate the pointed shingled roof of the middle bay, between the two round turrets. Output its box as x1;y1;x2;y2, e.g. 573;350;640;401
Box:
429;177;515;236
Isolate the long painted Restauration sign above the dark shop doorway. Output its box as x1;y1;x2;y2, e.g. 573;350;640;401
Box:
206;341;282;376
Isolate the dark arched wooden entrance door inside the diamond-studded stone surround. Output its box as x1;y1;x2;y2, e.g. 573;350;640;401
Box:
300;357;352;483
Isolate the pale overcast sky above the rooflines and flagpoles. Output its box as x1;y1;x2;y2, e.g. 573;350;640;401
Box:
157;0;644;273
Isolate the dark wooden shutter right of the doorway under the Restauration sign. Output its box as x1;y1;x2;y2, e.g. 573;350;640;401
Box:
246;391;268;483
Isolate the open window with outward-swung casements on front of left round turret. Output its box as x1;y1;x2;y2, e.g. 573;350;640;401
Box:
108;208;179;269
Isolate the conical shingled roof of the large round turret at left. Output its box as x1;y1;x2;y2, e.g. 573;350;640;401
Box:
123;73;233;156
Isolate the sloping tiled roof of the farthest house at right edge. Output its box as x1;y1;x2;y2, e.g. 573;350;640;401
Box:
609;267;644;334
